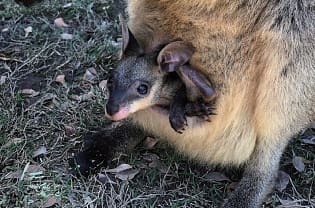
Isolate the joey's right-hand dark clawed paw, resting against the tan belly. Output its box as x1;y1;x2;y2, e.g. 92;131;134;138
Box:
185;101;215;122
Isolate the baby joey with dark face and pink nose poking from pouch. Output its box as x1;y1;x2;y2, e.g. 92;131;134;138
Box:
106;16;215;133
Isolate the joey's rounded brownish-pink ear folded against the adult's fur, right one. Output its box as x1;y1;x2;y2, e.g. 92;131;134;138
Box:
157;41;194;72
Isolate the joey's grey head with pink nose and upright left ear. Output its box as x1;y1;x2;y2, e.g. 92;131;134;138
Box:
106;16;165;120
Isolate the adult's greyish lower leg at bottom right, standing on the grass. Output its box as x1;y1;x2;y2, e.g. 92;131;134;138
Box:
223;136;288;208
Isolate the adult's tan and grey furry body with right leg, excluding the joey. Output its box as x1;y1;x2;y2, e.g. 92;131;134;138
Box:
128;0;315;207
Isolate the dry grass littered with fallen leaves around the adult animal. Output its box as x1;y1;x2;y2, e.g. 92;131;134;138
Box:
0;0;315;208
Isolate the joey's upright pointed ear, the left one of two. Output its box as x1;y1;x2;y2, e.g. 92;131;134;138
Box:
119;14;144;58
